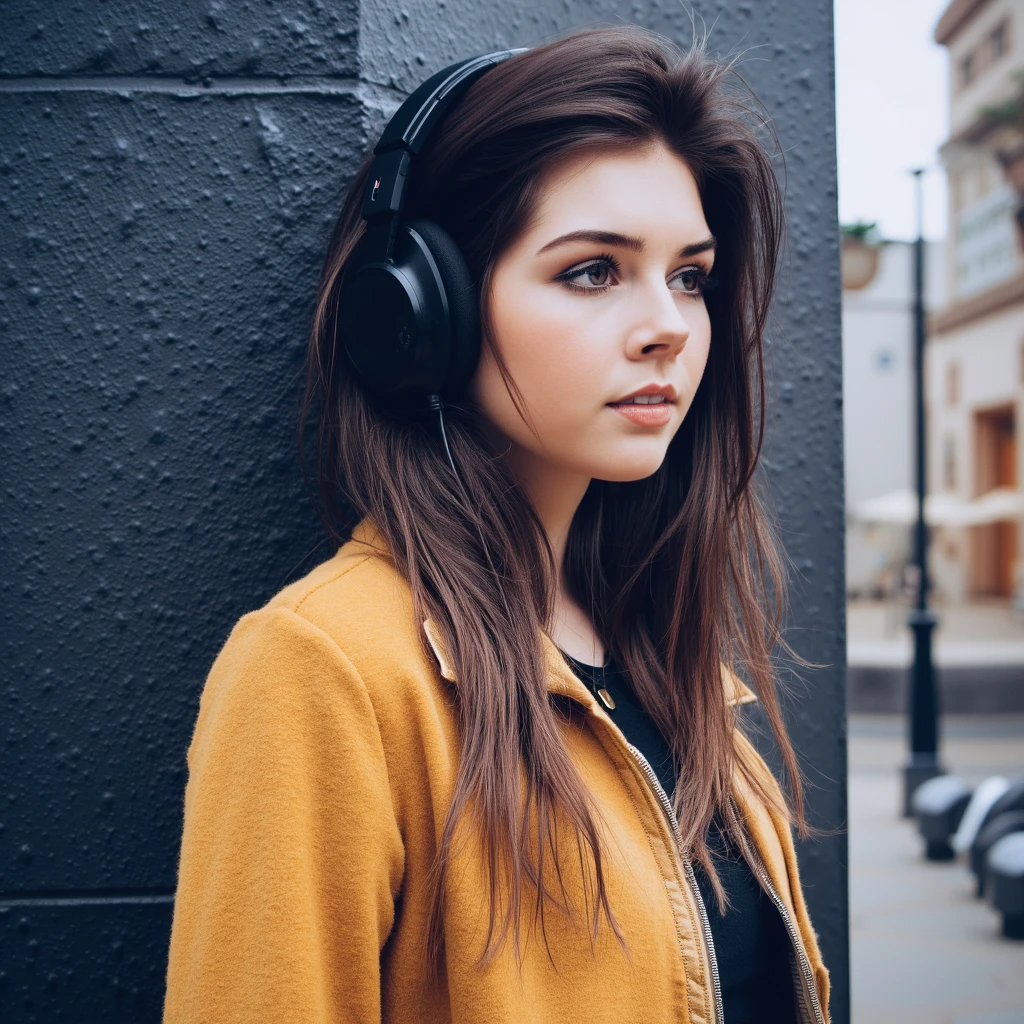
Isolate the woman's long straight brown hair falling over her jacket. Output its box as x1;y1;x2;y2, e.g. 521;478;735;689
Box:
299;28;803;966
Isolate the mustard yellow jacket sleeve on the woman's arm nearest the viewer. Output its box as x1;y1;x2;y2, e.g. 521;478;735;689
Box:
164;607;403;1024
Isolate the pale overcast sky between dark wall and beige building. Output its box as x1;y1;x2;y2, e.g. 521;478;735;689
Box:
835;0;949;239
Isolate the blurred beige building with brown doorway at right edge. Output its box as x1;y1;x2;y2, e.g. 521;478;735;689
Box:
926;0;1024;600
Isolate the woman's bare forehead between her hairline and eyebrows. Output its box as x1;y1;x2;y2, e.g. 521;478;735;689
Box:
528;142;710;241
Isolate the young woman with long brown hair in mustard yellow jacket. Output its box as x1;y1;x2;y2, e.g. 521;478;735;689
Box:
165;29;828;1024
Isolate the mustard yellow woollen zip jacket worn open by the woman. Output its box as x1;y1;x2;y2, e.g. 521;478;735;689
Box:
164;519;828;1024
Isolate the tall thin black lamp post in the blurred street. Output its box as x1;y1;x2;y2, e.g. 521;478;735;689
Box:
903;167;944;816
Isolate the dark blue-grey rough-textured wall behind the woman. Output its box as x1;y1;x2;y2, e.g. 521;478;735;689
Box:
0;0;848;1024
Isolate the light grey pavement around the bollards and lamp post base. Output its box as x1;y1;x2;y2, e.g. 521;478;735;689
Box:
849;715;1024;1024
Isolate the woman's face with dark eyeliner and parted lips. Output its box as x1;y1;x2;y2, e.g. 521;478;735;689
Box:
470;143;715;480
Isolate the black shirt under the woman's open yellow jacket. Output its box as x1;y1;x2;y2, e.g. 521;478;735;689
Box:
562;651;797;1024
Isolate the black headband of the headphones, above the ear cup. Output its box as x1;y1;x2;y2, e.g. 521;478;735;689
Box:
362;47;527;221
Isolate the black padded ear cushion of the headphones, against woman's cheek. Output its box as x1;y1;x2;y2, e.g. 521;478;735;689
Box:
407;217;480;399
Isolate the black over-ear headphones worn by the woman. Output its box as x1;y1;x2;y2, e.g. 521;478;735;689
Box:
335;49;523;405
